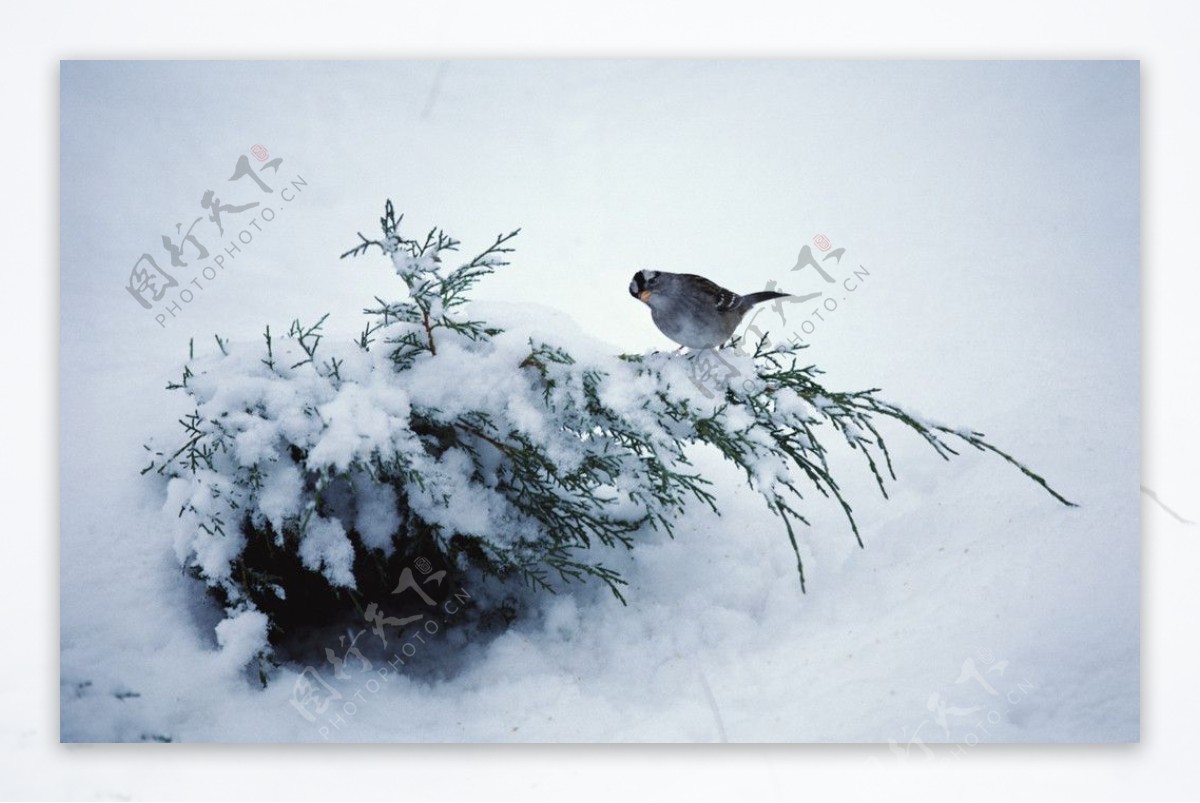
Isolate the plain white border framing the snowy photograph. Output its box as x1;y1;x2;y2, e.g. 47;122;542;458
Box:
11;0;1200;801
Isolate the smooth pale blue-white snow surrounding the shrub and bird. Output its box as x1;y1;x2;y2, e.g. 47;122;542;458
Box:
61;61;1140;761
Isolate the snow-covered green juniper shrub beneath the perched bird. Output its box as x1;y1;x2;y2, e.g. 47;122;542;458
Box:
144;202;1069;672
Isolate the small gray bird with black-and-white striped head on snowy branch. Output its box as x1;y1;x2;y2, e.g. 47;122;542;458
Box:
629;270;787;348
